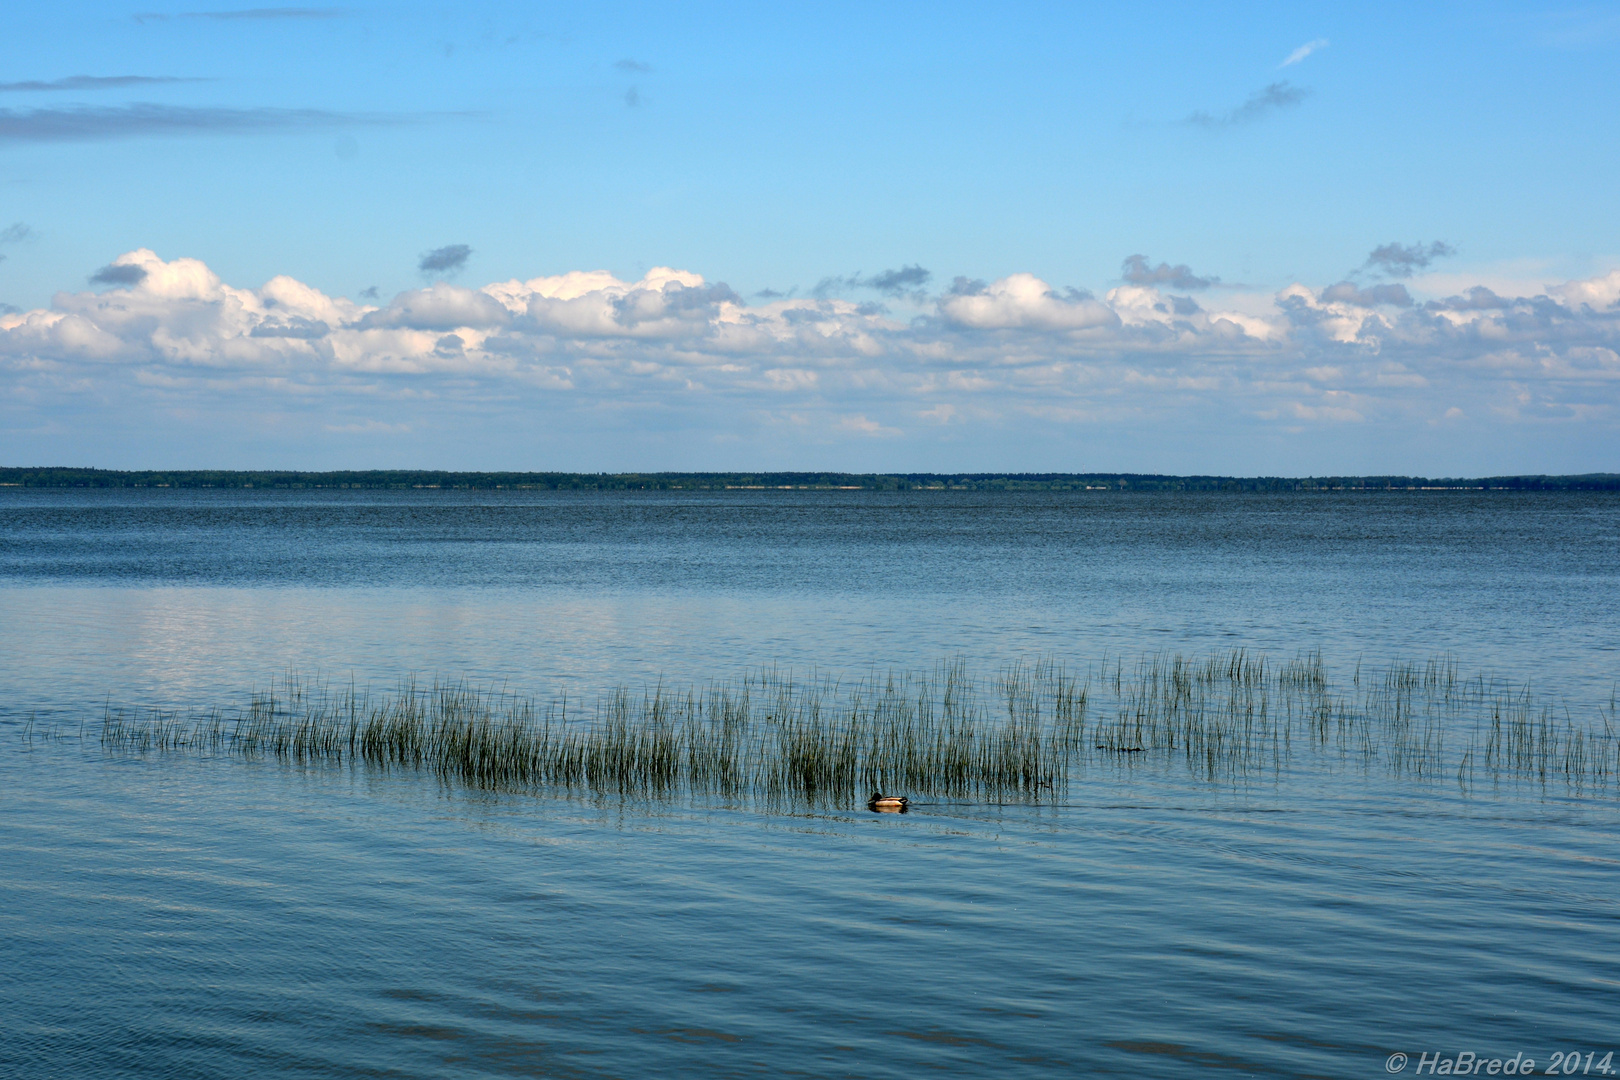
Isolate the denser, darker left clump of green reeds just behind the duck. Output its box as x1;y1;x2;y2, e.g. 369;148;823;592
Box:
100;662;1085;801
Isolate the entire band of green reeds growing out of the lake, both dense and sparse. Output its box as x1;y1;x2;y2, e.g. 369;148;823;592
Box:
100;649;1620;805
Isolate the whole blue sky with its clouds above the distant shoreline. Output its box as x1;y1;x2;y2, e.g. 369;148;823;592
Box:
0;0;1620;476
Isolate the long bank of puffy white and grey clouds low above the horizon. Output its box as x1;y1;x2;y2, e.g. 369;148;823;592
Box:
0;249;1620;453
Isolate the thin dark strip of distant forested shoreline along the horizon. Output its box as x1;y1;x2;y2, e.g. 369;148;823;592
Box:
0;468;1620;492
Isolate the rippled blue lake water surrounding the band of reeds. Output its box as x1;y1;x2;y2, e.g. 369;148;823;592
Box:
0;491;1620;1077
